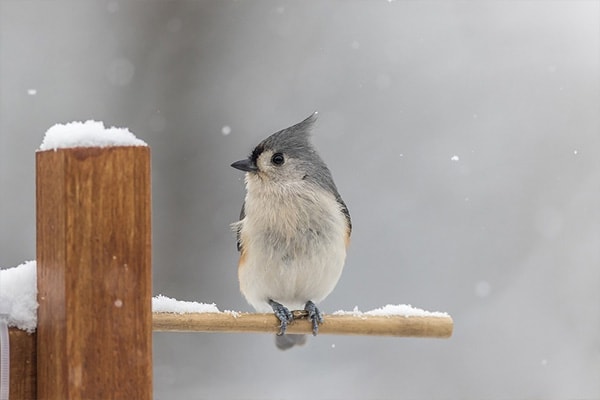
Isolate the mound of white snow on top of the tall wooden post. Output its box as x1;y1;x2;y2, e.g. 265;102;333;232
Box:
39;120;147;151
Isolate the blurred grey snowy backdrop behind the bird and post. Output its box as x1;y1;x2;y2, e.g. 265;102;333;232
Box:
0;0;600;400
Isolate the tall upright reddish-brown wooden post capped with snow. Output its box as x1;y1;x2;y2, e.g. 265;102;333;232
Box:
36;146;152;400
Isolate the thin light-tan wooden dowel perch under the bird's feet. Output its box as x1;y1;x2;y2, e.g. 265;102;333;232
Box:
152;313;454;338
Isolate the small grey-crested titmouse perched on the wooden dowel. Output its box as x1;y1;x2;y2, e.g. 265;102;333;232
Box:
231;113;352;350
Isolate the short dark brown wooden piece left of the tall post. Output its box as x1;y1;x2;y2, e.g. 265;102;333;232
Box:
8;328;37;400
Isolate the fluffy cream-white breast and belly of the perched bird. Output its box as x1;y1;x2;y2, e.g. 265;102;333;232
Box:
234;180;348;312
